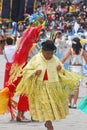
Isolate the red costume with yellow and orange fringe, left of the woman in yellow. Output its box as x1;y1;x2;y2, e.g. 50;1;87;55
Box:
0;25;42;118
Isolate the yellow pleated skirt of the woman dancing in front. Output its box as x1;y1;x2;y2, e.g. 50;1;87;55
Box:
16;78;68;121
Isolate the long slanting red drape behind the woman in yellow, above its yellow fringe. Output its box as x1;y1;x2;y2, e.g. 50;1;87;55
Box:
13;25;42;65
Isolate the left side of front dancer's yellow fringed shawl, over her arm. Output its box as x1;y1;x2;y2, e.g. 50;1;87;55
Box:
15;55;38;96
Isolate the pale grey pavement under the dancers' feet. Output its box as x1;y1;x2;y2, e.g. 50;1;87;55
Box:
0;55;87;130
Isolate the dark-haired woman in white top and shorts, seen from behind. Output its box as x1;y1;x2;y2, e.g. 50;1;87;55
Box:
61;37;87;108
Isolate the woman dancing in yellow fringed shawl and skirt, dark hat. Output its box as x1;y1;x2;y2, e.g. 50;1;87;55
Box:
15;40;81;130
